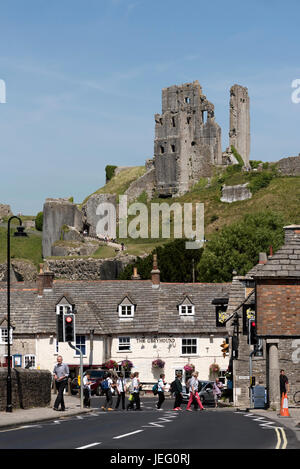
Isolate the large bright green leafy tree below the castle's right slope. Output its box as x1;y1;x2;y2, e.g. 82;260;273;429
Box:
197;211;284;282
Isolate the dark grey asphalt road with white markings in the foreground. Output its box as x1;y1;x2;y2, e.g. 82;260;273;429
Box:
0;398;297;450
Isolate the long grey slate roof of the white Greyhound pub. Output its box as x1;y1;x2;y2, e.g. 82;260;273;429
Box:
0;280;231;334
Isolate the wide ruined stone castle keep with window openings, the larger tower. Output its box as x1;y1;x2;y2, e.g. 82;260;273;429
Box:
154;81;222;197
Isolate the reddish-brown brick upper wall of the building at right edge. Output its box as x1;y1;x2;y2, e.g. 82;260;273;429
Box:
256;279;300;337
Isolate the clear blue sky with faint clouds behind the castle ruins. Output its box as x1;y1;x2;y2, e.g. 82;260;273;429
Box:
0;0;300;214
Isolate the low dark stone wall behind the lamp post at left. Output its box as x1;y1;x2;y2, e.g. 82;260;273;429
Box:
0;368;52;411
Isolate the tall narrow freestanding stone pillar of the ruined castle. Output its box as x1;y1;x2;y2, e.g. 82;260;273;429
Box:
229;85;250;167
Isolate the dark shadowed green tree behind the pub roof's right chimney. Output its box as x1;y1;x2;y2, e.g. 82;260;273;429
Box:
119;239;203;282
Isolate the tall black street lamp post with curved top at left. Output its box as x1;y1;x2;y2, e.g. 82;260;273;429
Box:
6;216;27;412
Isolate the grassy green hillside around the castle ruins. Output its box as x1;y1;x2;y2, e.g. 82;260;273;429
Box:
0;163;300;266
